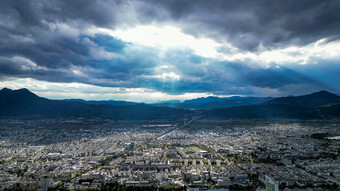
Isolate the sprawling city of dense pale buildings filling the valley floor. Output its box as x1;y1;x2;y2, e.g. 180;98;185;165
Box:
0;120;340;191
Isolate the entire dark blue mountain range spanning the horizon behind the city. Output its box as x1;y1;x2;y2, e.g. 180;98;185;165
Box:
0;88;340;120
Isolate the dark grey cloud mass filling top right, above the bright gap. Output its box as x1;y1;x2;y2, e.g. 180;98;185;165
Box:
149;0;340;50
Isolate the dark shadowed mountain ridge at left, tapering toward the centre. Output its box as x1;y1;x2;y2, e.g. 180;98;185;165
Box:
0;88;190;120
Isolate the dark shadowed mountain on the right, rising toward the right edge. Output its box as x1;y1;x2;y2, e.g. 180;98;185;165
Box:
203;91;340;119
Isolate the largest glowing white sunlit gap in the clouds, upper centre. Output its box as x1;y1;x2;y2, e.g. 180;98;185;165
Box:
90;25;221;57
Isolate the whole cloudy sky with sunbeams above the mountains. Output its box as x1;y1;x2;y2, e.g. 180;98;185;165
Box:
0;0;340;103
